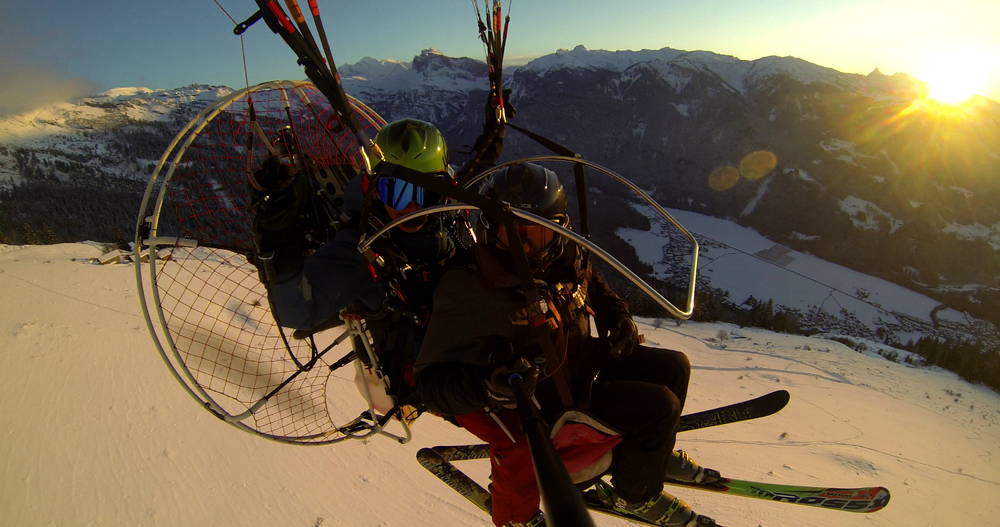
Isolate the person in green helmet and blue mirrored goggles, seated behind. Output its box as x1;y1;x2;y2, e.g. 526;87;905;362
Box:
251;119;456;407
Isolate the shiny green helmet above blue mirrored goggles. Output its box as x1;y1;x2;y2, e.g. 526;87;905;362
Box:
372;119;448;173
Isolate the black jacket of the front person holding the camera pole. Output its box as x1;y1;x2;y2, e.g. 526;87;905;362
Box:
414;244;628;415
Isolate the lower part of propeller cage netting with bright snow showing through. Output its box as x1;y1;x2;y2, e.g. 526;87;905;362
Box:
156;248;335;439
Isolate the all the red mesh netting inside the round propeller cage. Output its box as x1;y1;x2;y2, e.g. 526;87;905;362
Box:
143;83;384;443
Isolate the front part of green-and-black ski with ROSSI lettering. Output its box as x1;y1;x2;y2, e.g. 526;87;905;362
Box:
664;478;889;513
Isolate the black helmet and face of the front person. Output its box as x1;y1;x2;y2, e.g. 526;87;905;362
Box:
485;163;569;269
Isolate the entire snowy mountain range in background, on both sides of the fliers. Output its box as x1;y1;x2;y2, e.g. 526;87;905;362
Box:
0;46;1000;342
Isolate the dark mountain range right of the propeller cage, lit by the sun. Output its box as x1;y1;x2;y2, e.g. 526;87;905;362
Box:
341;46;1000;334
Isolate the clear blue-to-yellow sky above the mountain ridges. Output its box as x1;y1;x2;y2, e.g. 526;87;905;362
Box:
0;0;1000;111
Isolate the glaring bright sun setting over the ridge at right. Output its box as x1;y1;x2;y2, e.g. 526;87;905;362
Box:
921;52;989;104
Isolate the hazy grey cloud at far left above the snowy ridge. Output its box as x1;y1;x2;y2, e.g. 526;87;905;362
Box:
0;66;95;117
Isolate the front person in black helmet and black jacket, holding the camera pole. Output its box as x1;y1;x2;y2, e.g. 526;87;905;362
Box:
414;163;715;526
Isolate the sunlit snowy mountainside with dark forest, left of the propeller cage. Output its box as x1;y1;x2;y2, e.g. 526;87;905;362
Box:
0;85;233;243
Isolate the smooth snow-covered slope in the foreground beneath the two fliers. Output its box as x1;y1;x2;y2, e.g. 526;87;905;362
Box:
0;244;1000;527
